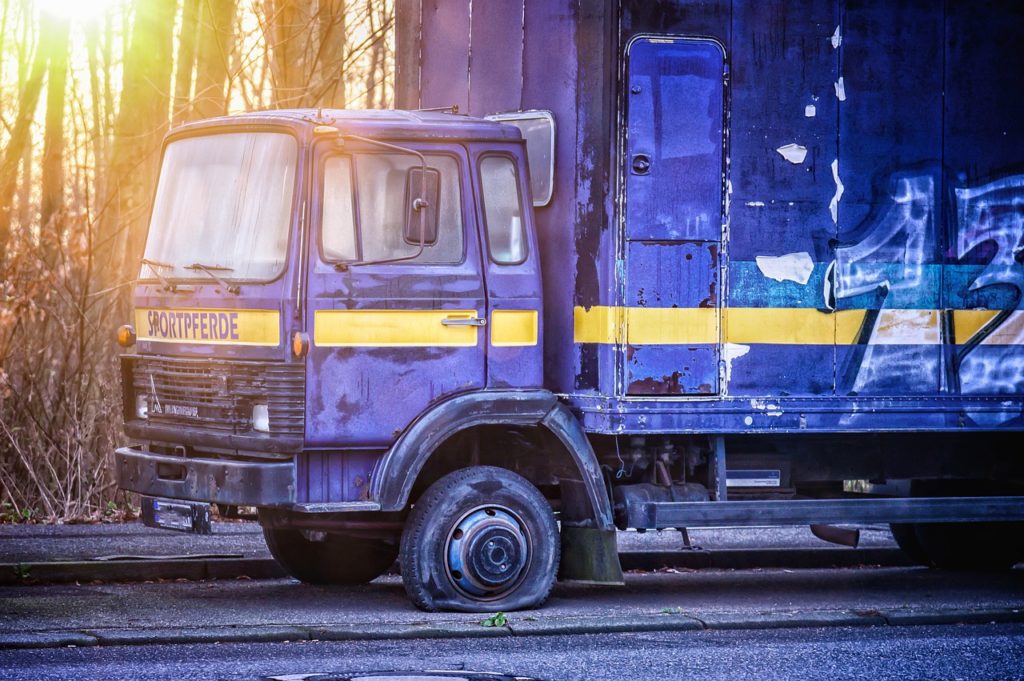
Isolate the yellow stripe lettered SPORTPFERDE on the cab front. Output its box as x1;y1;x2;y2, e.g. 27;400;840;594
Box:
135;307;281;345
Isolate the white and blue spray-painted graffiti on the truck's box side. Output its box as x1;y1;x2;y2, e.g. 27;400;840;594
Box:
824;167;1024;394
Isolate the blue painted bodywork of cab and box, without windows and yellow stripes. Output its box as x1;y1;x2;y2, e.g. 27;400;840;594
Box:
128;0;1024;503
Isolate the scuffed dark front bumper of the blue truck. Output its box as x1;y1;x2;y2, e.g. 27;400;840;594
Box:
114;446;295;506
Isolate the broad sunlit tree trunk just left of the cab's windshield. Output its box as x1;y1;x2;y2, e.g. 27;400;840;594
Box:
97;0;177;283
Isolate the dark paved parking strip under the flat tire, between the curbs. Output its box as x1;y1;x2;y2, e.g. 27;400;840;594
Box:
0;568;1024;648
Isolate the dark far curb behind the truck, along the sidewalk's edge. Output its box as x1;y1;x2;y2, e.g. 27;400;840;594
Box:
0;547;912;587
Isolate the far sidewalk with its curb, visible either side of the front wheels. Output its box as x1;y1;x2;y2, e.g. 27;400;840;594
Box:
0;522;908;586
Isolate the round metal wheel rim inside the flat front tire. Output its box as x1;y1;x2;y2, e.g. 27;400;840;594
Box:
446;506;530;598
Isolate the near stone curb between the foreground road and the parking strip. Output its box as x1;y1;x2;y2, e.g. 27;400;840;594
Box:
0;608;1024;649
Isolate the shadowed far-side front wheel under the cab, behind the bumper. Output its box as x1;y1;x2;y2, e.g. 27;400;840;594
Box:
263;527;398;584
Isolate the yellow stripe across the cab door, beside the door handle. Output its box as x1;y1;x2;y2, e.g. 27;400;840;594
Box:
313;309;479;347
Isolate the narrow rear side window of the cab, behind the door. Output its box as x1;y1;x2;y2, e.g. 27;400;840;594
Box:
480;156;526;265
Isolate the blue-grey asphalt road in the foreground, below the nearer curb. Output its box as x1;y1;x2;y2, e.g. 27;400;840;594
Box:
0;624;1024;681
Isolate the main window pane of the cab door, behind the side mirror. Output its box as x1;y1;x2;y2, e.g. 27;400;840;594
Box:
355;154;463;263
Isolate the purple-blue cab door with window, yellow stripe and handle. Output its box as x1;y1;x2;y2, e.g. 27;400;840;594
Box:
306;141;486;448
